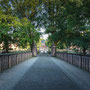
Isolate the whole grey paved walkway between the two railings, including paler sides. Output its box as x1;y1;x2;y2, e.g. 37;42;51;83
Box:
0;54;90;90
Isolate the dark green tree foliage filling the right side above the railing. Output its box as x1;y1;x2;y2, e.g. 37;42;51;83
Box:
42;0;90;53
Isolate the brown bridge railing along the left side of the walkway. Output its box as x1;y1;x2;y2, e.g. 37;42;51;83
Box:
0;51;32;72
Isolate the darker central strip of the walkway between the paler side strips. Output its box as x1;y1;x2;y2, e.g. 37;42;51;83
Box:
13;53;81;90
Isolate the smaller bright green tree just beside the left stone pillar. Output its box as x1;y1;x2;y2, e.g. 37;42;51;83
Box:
18;18;40;51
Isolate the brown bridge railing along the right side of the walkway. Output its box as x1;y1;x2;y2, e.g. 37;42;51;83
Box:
56;52;90;72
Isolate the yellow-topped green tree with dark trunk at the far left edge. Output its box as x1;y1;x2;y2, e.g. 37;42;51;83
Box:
0;12;20;53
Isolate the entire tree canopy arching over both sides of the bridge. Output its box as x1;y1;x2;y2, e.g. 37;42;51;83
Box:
0;0;90;53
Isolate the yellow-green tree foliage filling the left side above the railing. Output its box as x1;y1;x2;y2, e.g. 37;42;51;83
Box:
0;0;40;53
